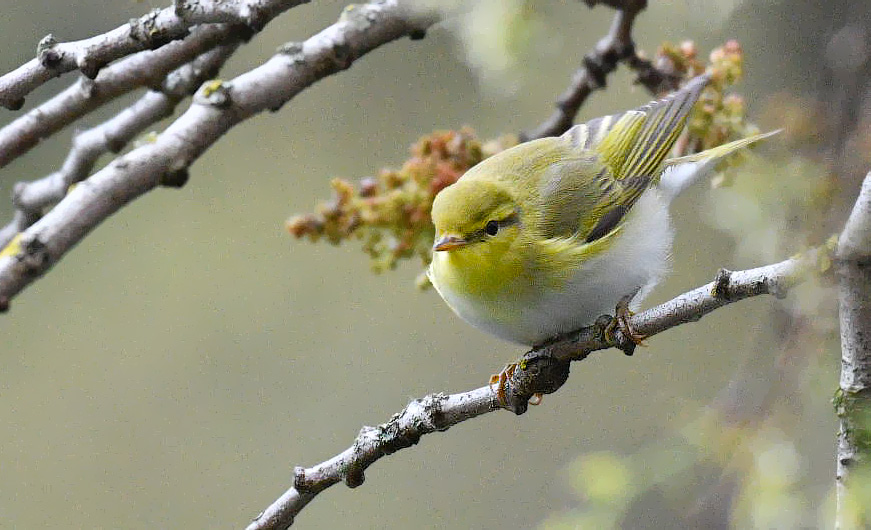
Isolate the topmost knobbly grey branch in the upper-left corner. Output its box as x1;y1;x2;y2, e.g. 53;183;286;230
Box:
0;0;308;110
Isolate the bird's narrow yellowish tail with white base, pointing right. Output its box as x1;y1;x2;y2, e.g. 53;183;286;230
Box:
659;129;780;201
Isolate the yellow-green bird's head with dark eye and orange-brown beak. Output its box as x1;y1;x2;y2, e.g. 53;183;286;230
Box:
432;179;520;252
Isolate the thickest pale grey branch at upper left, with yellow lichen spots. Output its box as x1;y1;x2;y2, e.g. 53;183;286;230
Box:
0;0;438;308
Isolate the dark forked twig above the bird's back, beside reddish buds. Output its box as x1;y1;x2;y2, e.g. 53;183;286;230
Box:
520;0;679;142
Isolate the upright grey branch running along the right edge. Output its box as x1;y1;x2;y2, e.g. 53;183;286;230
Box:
834;169;871;528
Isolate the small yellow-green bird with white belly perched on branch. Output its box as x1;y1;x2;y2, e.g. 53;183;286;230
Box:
428;76;773;346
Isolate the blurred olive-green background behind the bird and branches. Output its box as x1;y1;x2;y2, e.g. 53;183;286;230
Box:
0;0;871;529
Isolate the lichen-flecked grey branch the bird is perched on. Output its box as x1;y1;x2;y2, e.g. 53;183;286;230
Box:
247;251;819;530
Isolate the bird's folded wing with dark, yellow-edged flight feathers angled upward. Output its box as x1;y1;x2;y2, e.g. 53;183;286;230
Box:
541;76;708;242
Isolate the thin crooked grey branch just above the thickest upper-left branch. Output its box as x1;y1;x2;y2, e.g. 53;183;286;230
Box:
0;42;239;248
